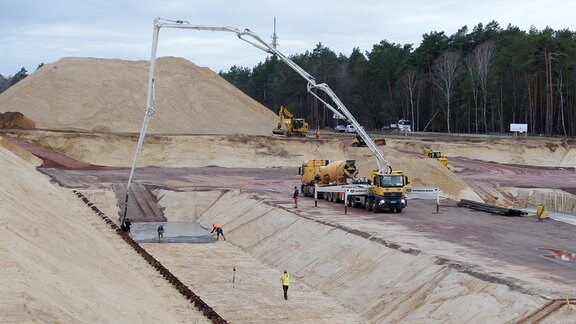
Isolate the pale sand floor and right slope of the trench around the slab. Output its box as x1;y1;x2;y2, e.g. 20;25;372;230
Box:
146;191;545;323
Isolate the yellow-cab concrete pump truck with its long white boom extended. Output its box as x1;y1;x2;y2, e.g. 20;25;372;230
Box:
122;18;410;224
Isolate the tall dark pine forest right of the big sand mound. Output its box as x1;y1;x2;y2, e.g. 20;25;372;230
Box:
220;21;576;136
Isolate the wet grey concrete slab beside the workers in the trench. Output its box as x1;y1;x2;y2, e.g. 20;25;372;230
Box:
130;222;216;243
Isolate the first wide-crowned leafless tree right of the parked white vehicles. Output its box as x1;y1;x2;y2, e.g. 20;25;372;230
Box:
432;52;461;133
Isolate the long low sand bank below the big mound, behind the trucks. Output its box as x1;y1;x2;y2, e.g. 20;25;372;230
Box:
12;131;480;201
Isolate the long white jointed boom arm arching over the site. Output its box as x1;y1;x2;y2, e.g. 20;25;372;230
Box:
122;18;392;223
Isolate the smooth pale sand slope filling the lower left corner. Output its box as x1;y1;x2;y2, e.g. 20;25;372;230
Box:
0;146;208;323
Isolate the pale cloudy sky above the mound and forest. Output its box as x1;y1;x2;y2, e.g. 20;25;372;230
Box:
0;0;576;76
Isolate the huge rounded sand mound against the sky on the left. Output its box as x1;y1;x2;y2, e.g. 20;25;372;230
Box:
0;57;276;135
